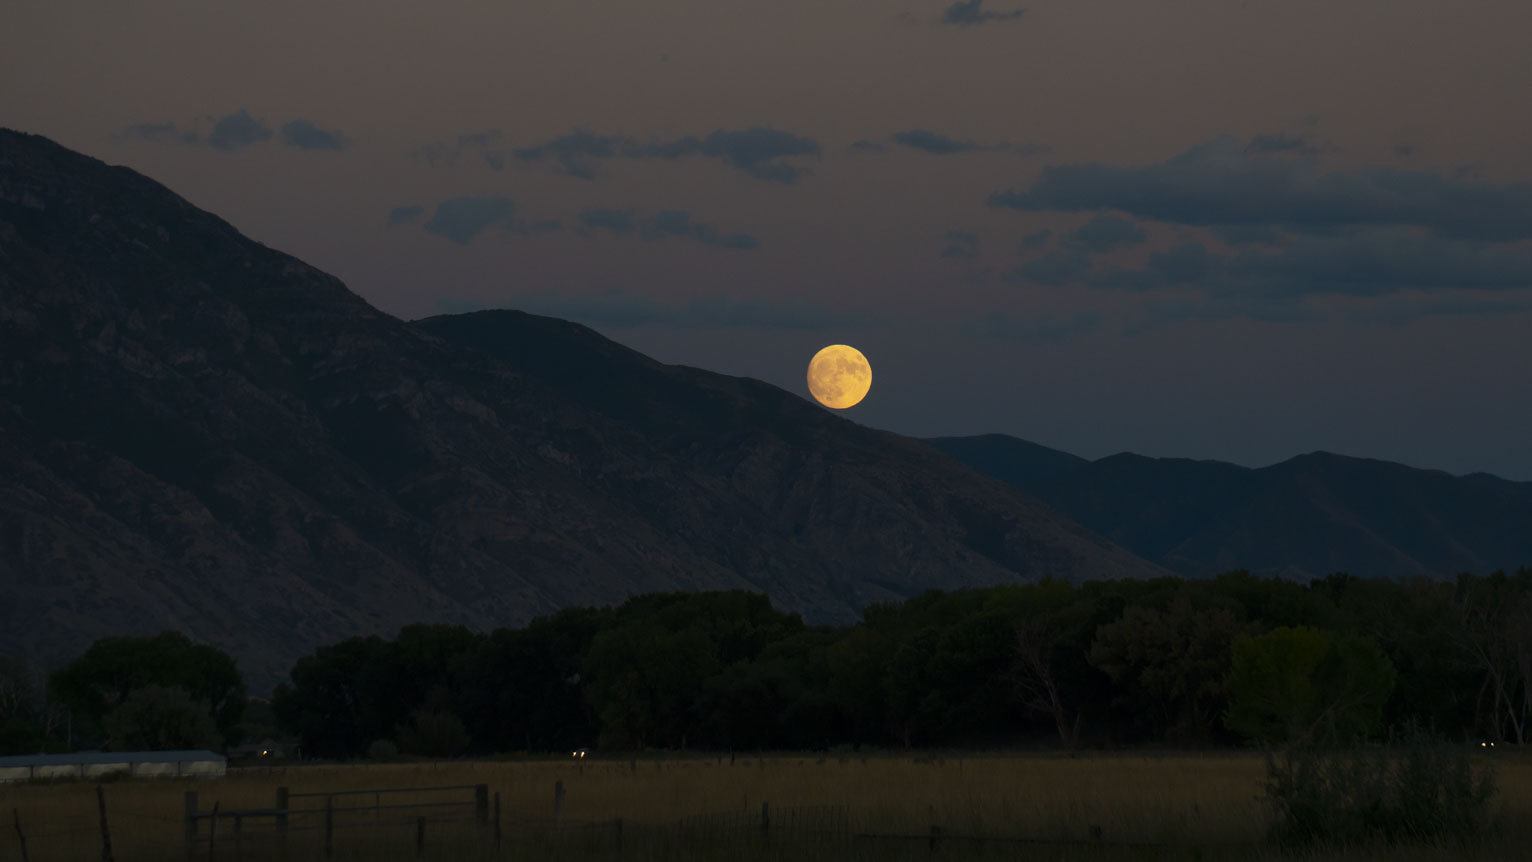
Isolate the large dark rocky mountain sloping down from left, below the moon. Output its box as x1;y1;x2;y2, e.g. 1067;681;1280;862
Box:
0;130;1163;691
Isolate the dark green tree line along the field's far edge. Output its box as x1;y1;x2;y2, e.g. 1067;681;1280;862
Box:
0;568;1532;758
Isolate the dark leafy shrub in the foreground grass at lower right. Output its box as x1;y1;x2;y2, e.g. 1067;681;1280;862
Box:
1265;727;1495;848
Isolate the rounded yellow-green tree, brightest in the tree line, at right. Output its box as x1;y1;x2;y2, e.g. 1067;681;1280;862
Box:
1224;626;1394;747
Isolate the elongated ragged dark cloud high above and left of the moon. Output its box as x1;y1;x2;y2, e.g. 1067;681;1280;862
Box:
513;126;820;184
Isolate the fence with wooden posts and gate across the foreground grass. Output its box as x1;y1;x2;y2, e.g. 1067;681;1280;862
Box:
0;781;1261;862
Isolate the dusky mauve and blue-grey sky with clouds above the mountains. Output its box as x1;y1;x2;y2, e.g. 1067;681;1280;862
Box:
0;0;1532;479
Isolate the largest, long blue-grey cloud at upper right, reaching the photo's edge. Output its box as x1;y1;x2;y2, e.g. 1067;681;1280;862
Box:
990;138;1532;240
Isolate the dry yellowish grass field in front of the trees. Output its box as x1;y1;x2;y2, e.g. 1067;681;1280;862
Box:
0;755;1532;862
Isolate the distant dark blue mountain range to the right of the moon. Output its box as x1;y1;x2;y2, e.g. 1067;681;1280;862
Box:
930;435;1532;577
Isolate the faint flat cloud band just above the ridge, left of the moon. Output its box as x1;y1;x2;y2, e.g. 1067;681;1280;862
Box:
471;291;870;331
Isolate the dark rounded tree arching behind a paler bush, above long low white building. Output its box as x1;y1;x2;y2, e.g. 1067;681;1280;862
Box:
49;631;245;743
